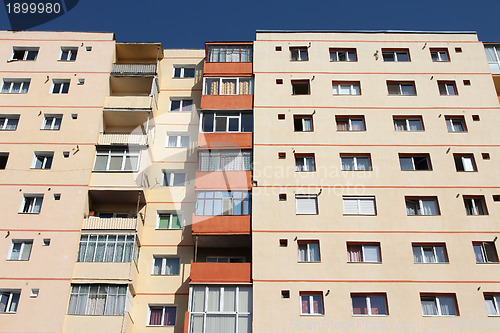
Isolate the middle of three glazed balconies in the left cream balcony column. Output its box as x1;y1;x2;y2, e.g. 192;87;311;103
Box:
76;235;138;262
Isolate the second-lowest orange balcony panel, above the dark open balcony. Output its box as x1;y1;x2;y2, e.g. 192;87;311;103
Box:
192;214;251;235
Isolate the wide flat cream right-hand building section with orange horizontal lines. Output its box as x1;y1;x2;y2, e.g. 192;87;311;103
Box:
252;31;500;332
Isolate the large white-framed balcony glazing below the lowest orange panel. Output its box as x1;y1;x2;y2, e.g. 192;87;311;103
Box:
188;285;252;333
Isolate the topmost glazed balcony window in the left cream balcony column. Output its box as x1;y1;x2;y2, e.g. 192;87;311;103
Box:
94;148;141;171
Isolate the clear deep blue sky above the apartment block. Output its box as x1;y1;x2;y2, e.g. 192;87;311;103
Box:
0;0;500;48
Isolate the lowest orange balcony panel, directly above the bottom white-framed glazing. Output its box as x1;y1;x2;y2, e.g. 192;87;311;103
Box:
191;262;252;283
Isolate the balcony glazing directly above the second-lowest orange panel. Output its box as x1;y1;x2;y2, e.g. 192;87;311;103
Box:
196;191;252;216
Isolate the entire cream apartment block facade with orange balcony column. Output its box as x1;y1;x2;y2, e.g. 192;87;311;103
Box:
0;31;500;333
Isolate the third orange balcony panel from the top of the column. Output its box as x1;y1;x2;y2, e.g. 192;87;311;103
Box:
198;132;253;149
